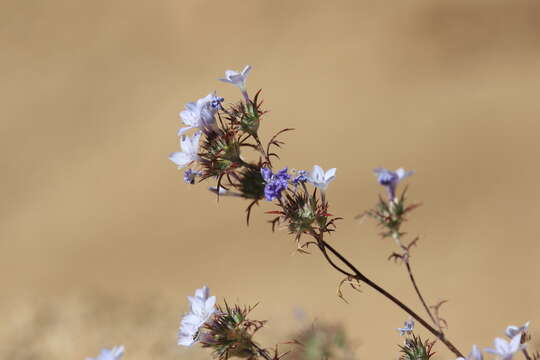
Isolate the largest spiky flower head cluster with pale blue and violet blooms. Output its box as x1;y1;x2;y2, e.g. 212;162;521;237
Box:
169;65;336;235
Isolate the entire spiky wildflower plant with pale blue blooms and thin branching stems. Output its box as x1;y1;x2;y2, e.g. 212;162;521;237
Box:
162;65;538;360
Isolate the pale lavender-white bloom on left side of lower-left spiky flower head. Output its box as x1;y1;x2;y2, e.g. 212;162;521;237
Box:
178;285;216;346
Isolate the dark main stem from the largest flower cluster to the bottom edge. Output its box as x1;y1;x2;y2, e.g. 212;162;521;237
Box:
312;233;463;357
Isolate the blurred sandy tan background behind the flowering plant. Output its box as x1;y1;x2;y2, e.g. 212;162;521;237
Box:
0;0;540;360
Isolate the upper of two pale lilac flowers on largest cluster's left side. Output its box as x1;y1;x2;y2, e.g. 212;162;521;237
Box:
178;93;223;136
